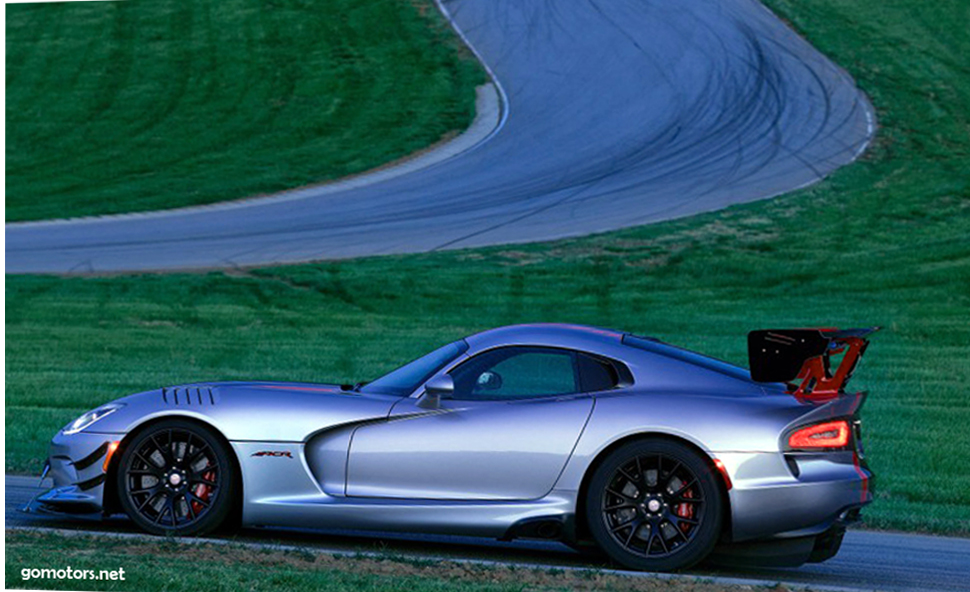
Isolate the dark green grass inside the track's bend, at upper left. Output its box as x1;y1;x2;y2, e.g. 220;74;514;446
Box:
6;0;484;221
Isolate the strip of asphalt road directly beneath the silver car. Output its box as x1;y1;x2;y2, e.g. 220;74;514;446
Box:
5;475;970;592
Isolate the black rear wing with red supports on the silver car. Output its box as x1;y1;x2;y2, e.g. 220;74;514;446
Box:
748;327;879;400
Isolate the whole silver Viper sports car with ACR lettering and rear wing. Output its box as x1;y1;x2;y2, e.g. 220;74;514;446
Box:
28;325;875;570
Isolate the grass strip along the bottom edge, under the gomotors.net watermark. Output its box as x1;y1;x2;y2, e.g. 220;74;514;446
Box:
4;531;764;592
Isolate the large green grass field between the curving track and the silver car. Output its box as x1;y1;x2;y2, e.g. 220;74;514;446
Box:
6;0;970;534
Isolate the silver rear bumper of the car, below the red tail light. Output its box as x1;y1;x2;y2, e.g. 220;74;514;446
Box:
717;452;872;542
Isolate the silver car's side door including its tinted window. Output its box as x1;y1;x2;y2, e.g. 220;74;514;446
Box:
346;346;593;500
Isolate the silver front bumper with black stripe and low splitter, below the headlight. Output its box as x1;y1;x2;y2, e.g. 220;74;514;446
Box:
24;432;122;514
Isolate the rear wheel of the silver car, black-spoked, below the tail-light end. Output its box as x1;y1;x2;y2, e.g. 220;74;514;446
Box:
586;438;723;571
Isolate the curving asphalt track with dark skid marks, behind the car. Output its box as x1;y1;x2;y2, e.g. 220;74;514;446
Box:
6;0;874;273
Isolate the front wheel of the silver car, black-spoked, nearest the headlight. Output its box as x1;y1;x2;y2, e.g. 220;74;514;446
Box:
117;419;238;536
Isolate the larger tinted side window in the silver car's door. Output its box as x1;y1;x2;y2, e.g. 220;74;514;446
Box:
451;347;582;400
